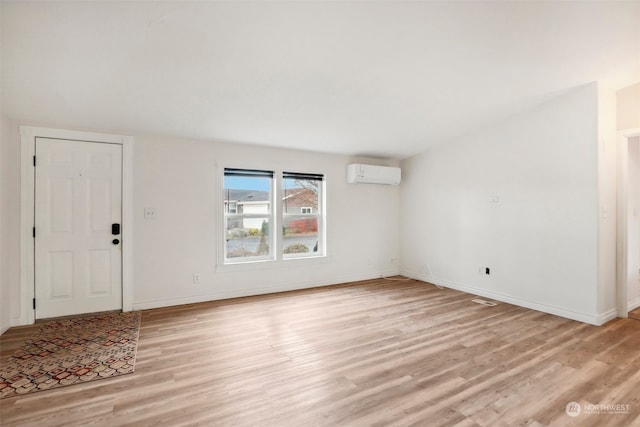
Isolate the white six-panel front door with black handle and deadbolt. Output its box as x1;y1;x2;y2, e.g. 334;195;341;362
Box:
34;138;122;319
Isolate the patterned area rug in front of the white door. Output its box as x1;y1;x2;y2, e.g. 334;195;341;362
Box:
0;312;140;398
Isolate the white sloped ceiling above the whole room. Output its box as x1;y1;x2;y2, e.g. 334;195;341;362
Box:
1;1;640;158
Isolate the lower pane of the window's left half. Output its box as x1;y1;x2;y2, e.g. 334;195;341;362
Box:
226;217;269;258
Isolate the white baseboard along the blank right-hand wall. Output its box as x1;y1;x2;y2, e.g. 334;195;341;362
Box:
402;271;616;326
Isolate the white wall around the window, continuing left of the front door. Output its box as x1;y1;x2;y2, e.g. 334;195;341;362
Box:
2;121;399;327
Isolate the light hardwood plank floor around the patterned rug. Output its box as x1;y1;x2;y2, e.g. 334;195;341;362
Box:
0;279;640;427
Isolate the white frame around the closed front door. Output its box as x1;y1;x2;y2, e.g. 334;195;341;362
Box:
20;126;134;325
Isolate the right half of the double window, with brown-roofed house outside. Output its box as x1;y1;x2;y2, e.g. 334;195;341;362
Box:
281;172;324;259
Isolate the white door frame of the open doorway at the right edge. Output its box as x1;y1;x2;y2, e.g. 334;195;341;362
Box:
616;128;640;318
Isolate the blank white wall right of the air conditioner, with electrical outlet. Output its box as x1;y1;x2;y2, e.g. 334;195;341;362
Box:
400;84;607;324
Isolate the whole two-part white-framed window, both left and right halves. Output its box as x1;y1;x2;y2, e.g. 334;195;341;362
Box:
223;168;326;264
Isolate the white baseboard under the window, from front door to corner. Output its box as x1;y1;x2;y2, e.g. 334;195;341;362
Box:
133;269;400;310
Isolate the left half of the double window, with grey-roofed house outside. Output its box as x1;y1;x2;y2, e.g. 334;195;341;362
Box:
224;168;274;263
